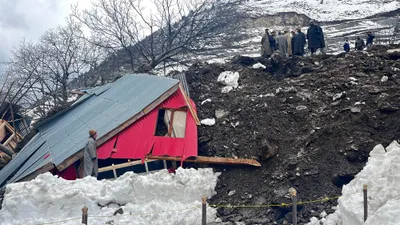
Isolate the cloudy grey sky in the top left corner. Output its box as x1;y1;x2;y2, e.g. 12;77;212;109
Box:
0;0;89;61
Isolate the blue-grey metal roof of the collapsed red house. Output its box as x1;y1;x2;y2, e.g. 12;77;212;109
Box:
0;74;179;186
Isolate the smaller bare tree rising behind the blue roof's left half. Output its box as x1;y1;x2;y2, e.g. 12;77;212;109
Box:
38;20;96;104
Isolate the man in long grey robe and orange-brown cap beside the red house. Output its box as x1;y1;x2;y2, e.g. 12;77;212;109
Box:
83;130;99;178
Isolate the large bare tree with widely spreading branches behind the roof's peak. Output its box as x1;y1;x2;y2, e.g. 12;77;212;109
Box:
72;0;239;71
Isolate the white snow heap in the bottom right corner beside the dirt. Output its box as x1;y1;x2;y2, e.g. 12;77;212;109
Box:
308;141;400;225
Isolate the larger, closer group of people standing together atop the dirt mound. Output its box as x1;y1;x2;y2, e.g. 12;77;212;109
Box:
261;20;325;57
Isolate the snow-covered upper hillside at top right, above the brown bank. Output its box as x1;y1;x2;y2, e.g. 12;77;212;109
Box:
242;0;400;21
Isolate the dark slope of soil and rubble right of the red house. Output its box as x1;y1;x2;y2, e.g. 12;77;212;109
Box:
186;46;400;224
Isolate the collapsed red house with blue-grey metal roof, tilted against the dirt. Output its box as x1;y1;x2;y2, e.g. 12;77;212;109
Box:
0;74;259;186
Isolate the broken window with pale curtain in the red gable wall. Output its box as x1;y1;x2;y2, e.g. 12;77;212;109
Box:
155;108;187;138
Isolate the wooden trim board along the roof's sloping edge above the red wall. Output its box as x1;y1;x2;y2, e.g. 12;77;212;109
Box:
57;84;179;171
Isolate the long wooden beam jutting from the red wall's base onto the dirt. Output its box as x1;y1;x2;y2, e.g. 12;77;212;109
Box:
147;156;261;167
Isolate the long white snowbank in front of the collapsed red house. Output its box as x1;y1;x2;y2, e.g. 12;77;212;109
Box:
0;168;219;225
